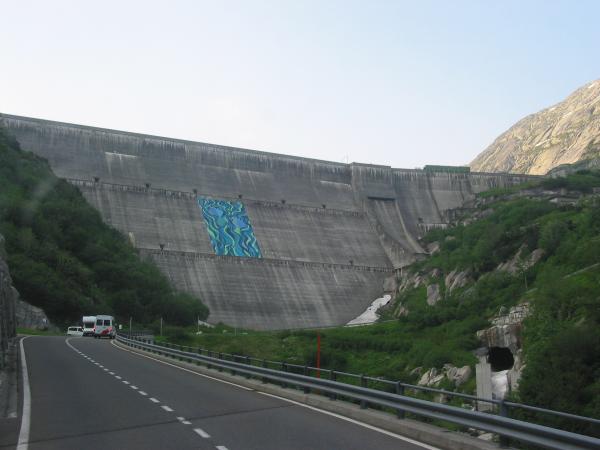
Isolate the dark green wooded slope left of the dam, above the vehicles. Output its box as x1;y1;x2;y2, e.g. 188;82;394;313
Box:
0;130;208;325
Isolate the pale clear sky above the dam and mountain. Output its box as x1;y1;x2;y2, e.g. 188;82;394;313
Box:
0;0;600;168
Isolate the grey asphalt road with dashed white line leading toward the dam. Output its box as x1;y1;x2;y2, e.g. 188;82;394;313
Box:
7;337;438;450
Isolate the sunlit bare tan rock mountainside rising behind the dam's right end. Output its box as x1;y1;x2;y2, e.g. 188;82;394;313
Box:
470;80;600;175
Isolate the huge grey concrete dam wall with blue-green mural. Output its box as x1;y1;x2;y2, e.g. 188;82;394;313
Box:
0;114;530;329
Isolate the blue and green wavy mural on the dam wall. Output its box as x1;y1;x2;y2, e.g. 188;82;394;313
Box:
198;198;262;258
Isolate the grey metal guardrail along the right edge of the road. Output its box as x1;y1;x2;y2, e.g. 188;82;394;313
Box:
117;335;600;450
